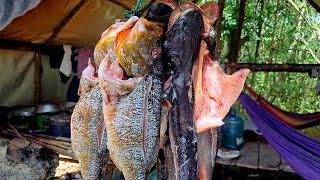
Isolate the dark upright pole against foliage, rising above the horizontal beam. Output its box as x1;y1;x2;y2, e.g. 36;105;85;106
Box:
230;0;246;63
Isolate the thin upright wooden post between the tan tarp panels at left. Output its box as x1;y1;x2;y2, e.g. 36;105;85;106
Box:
34;52;41;107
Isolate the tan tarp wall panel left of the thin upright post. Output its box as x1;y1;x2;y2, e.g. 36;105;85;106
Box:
0;50;35;107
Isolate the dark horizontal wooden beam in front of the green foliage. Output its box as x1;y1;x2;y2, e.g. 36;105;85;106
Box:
222;63;320;73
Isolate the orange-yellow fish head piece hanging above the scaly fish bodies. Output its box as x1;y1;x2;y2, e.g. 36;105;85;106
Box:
94;16;163;77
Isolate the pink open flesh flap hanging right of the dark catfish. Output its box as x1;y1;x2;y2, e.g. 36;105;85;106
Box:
194;45;250;132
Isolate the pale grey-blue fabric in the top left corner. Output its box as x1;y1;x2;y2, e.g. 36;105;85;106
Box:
0;0;40;30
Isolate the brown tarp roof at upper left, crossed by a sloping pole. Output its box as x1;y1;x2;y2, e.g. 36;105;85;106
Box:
0;0;136;47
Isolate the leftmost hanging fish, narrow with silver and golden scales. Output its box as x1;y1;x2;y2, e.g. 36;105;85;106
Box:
71;60;108;179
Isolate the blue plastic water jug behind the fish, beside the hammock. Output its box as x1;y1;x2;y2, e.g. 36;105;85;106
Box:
221;108;244;150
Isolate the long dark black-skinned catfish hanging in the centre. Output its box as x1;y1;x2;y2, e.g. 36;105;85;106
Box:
165;4;204;179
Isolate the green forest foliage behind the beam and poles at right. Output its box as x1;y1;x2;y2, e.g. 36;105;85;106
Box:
222;0;320;118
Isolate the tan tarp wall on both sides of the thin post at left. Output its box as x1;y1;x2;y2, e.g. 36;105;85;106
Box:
0;49;76;107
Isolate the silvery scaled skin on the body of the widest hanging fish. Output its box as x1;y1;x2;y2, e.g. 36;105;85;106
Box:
107;76;162;179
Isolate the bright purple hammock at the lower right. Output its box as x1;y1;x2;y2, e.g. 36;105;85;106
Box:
240;93;320;179
